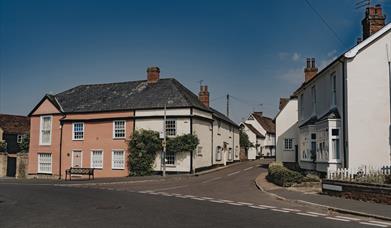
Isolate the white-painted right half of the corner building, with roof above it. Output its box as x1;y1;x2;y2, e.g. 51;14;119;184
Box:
134;68;240;172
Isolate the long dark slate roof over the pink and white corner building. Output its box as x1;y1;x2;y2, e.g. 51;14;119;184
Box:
54;78;211;113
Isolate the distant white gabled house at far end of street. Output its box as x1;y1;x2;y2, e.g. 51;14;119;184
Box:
241;112;276;159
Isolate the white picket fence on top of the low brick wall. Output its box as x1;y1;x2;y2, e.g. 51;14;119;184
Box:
327;166;391;184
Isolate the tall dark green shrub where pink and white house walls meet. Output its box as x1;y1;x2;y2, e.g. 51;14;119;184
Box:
128;130;162;176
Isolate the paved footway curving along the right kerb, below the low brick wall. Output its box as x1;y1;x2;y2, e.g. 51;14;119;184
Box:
256;168;391;221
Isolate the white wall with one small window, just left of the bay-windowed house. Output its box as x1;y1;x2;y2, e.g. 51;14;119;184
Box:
276;99;298;162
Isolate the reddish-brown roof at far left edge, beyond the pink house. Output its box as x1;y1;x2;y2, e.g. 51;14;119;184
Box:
0;114;30;134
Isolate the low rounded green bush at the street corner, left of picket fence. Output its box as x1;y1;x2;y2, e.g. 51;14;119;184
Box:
267;163;304;187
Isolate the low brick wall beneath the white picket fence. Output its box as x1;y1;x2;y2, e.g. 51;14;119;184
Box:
322;179;391;205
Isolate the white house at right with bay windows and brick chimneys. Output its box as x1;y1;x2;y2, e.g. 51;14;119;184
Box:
294;5;391;172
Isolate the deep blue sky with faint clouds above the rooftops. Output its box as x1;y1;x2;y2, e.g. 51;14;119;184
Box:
0;0;391;121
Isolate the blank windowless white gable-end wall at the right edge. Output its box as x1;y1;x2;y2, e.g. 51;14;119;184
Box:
346;29;391;168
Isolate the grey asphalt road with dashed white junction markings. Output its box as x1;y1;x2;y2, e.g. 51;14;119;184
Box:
0;161;388;228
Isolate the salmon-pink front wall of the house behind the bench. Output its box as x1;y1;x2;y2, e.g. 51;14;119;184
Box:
28;101;133;178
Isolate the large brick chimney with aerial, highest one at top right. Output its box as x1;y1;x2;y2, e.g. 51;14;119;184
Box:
361;4;386;40
